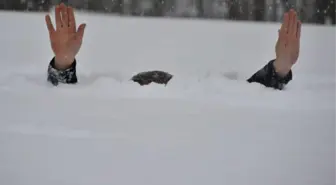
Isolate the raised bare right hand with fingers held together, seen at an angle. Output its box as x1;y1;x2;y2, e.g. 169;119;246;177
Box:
274;10;301;76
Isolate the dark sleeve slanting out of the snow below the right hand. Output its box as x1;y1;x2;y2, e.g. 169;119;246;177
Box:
247;60;293;90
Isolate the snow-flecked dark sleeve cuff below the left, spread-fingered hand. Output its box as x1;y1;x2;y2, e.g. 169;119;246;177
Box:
48;58;77;86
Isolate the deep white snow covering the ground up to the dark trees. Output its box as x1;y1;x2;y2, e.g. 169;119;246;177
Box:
0;12;336;185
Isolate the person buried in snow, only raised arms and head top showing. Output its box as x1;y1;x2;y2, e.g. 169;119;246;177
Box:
45;3;301;90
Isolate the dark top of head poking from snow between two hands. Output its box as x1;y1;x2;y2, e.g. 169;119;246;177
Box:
131;71;173;86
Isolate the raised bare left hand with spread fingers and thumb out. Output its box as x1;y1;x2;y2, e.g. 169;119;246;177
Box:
45;3;86;69
